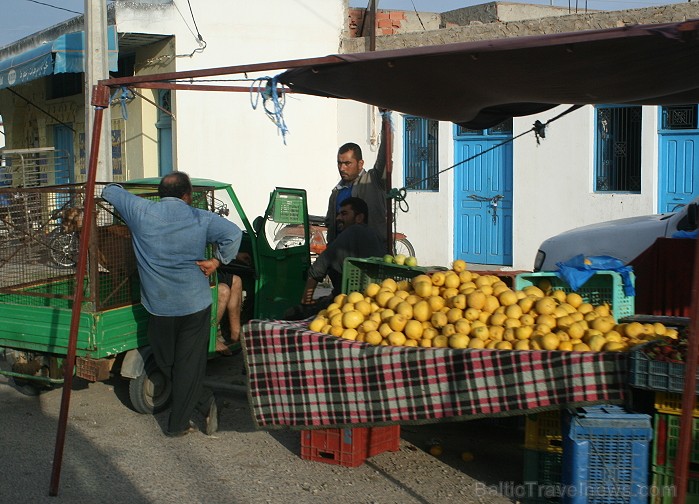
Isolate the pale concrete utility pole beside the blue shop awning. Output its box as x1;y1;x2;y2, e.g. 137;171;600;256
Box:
84;0;112;183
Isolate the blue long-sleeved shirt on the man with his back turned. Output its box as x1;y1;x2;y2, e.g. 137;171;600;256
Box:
102;184;243;317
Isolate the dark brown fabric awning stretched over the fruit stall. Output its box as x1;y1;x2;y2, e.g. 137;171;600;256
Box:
279;20;699;129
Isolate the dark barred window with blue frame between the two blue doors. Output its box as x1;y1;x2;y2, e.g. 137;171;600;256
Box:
595;106;641;192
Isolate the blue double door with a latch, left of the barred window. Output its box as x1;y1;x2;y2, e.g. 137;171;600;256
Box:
454;120;512;266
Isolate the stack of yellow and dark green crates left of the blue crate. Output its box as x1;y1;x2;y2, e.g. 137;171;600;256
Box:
522;410;563;504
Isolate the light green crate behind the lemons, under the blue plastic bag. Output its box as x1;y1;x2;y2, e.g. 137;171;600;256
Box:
515;271;635;320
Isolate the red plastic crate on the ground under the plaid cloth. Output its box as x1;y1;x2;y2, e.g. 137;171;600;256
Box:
301;425;400;467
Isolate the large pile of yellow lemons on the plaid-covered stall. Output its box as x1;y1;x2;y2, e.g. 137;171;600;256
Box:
309;260;677;352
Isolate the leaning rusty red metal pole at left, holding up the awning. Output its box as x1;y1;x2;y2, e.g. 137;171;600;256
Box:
49;86;109;496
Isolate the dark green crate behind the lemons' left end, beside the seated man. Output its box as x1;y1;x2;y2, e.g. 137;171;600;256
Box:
342;257;445;294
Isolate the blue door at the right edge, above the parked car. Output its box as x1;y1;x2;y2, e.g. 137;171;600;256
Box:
658;105;699;213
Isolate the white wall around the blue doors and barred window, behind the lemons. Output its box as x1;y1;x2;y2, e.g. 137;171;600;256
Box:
340;103;658;270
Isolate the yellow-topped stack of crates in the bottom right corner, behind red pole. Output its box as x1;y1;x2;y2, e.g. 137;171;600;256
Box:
651;392;699;504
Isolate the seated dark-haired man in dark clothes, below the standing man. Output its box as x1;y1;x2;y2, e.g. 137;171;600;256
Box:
301;197;385;305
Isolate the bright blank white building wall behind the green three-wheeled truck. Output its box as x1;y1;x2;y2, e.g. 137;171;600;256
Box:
116;0;345;219
